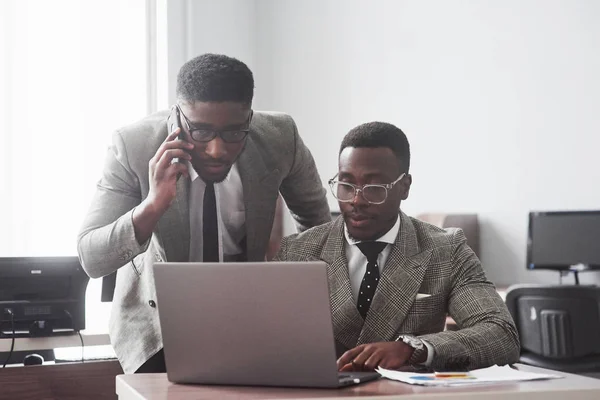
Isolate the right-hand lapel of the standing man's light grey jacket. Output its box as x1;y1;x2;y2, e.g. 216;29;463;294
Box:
238;130;280;261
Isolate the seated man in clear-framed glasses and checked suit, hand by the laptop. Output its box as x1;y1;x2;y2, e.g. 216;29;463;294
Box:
276;122;519;371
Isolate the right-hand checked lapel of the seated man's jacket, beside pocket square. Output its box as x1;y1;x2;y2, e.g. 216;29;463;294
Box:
358;212;432;344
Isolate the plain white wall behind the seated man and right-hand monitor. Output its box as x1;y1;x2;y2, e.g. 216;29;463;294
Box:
253;0;600;285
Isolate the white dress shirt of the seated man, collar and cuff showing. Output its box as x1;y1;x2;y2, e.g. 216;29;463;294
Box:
344;218;433;367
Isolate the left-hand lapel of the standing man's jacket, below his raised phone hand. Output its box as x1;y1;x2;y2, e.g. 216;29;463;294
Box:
158;177;190;262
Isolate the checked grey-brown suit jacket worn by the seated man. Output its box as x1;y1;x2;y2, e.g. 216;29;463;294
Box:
276;212;520;369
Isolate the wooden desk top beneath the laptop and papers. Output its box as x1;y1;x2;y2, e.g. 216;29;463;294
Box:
116;364;600;400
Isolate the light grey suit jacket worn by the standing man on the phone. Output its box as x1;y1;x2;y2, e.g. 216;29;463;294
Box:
78;108;331;373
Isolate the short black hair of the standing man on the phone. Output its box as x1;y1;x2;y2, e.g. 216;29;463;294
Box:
176;53;254;106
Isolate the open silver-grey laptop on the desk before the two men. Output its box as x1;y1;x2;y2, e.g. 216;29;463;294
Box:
154;262;380;388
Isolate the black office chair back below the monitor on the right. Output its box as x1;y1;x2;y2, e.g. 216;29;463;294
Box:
506;285;600;374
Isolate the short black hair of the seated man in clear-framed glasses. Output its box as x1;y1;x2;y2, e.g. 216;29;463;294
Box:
340;121;410;174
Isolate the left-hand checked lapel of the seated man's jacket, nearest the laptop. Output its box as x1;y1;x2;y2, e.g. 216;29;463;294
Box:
321;216;363;349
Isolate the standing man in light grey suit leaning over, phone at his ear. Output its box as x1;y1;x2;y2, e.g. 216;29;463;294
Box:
78;54;331;373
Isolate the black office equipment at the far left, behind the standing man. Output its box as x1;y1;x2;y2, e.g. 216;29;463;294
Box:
0;257;89;337
